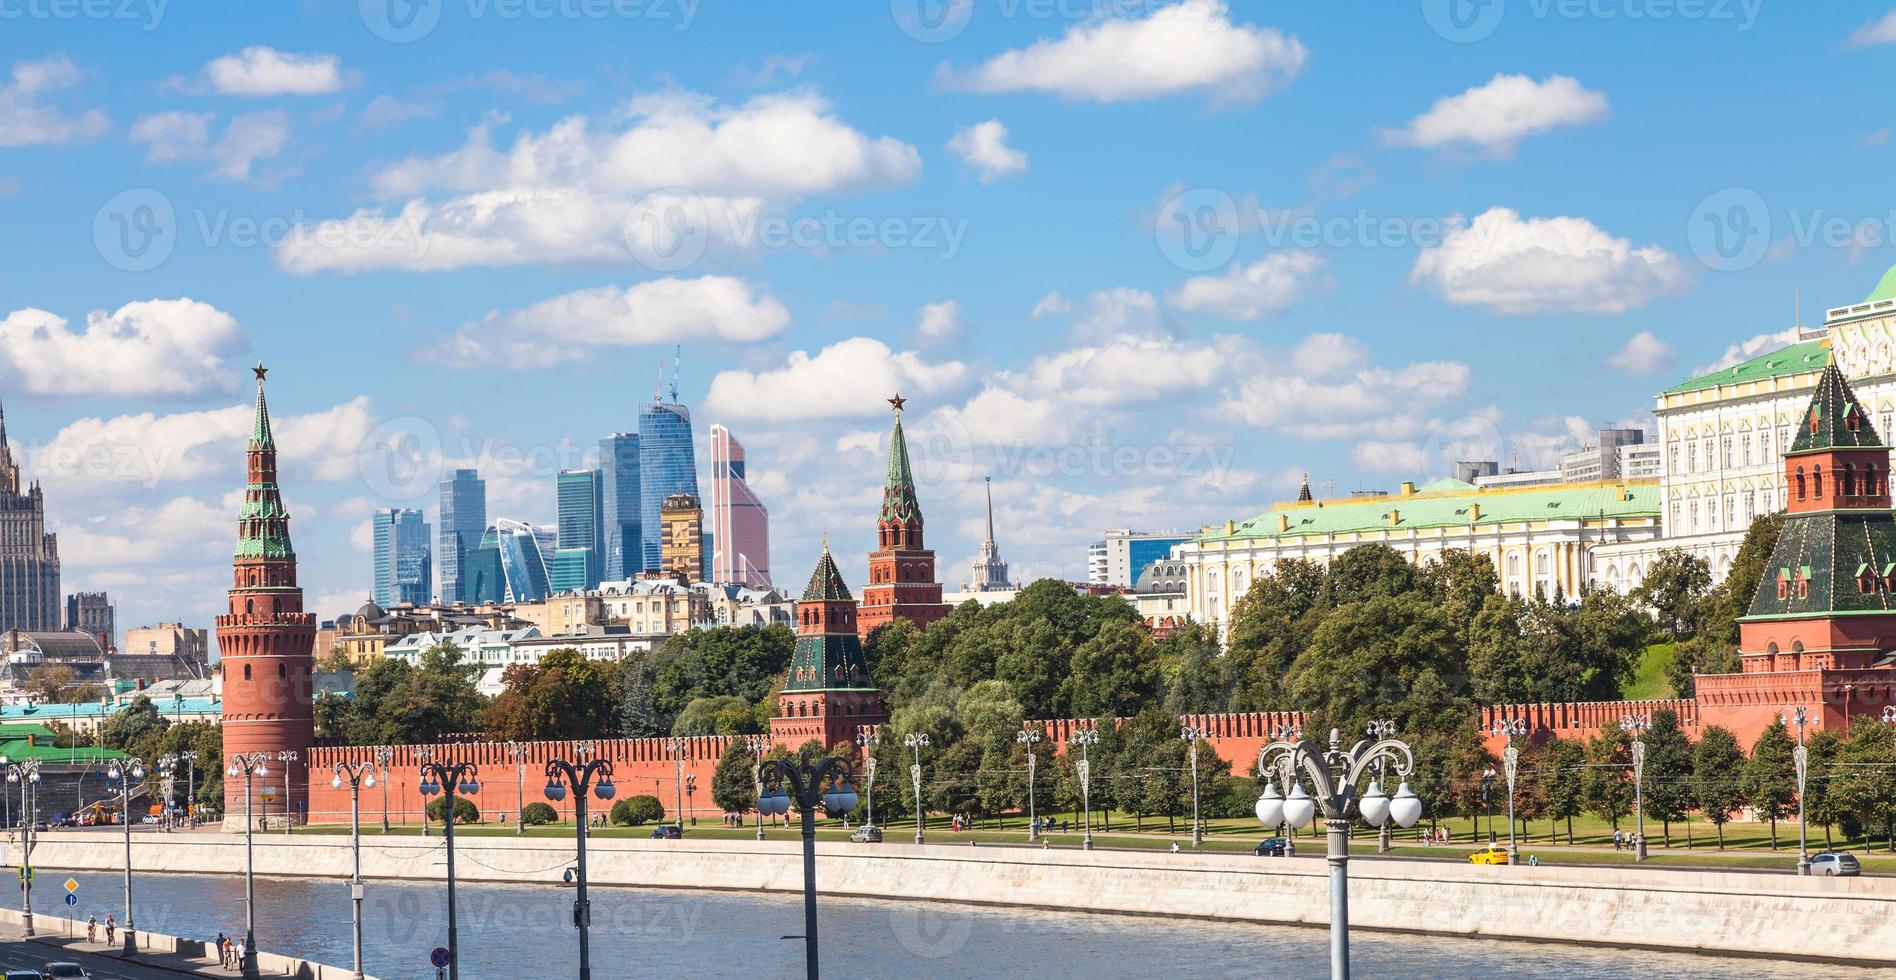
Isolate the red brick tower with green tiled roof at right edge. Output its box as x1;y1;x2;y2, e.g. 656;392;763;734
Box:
1695;364;1896;739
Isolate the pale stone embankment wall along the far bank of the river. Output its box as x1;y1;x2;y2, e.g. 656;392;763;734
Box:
7;834;1896;963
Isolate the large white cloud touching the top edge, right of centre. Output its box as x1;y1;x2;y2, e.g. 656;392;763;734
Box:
940;0;1308;102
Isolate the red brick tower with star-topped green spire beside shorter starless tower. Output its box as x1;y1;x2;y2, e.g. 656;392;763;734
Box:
857;394;948;637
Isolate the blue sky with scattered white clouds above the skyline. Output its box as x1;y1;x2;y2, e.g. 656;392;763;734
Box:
0;0;1896;624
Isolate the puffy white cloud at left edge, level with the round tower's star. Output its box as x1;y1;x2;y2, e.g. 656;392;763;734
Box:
0;299;250;396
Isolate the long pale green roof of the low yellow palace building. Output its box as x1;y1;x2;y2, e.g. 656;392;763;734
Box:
1196;480;1659;540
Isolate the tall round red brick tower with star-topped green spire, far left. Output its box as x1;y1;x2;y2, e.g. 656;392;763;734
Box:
218;364;317;828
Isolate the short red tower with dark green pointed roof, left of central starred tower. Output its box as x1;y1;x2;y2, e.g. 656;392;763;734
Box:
770;540;889;749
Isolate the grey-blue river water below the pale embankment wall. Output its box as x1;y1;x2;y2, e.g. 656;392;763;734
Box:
34;868;1888;980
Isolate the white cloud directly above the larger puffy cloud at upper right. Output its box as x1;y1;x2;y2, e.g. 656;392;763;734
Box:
1384;74;1608;157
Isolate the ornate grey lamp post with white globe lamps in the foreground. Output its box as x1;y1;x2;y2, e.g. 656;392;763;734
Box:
1257;728;1422;980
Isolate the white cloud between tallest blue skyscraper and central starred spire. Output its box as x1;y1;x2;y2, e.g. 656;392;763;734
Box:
705;337;967;419
